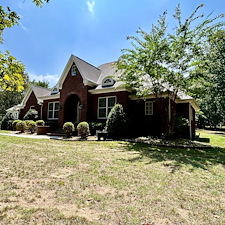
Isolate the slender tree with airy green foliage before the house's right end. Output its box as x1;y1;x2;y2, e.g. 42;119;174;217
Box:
117;5;224;137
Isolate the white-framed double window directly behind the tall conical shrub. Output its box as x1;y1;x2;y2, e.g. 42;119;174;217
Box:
98;96;116;119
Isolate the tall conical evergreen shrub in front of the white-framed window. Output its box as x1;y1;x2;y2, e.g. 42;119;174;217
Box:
106;104;126;139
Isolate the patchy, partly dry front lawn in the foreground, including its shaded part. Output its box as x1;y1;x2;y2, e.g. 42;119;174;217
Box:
0;136;225;225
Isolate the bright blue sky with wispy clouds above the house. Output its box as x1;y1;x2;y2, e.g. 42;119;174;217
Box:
0;0;225;87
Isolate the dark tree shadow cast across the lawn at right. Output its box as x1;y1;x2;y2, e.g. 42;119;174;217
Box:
122;143;225;172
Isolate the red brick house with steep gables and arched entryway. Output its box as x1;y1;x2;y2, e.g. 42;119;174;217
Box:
10;55;198;138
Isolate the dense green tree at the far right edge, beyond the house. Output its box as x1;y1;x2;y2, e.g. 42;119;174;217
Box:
193;29;225;128
